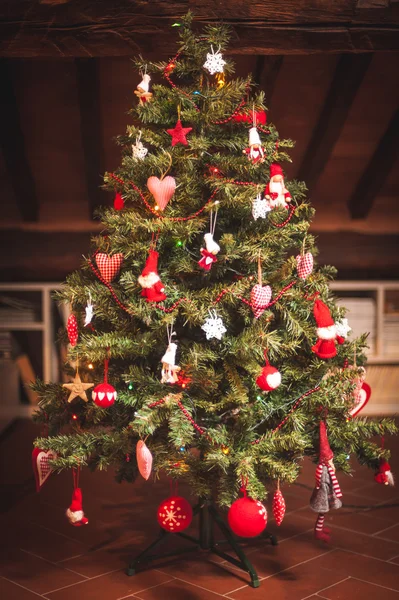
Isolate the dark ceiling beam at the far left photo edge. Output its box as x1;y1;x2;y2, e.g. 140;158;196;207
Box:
0;60;39;221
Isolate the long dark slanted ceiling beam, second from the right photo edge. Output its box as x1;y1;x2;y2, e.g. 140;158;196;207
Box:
297;54;372;193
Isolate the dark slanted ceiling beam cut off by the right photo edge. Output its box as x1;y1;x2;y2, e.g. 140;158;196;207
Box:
348;109;399;219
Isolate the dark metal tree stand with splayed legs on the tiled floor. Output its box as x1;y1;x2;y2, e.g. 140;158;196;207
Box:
126;500;278;587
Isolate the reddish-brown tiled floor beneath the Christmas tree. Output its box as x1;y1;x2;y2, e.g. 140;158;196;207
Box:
0;421;399;600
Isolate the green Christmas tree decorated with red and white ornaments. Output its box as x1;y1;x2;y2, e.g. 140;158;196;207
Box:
35;15;395;532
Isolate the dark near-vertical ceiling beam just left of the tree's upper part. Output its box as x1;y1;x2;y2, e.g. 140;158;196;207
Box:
75;58;106;218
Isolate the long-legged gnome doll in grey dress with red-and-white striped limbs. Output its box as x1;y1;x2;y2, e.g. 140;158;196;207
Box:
310;421;342;542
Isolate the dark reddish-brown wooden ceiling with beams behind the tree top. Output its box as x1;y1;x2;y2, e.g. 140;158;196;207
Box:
0;0;399;280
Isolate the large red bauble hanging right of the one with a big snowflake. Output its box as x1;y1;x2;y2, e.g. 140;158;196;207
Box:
227;496;267;537
